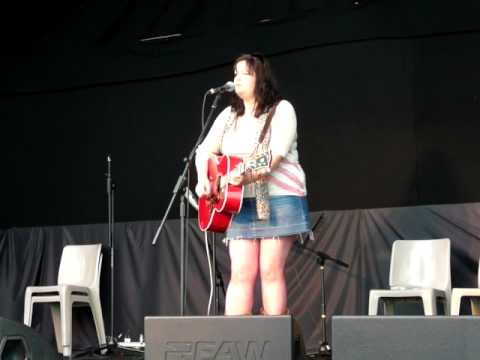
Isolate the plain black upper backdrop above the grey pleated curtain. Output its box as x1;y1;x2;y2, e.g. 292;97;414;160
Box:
0;0;480;228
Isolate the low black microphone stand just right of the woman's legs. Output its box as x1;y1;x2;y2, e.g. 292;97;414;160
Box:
295;214;349;356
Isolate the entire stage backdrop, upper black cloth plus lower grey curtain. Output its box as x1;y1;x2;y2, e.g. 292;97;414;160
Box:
0;0;480;348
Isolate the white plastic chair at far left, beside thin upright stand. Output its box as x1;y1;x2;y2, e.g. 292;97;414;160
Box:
23;244;106;356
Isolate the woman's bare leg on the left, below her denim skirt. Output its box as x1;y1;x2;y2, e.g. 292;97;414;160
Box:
225;240;260;315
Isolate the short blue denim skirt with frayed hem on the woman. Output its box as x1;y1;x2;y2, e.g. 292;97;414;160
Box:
226;195;310;240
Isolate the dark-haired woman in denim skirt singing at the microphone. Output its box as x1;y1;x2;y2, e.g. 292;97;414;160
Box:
196;55;310;315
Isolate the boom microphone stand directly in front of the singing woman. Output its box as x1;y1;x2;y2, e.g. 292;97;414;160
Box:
152;93;221;316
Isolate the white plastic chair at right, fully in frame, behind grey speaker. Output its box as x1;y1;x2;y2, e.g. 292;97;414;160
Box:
368;239;452;315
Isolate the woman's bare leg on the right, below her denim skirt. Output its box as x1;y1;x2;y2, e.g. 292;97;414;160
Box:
260;237;295;315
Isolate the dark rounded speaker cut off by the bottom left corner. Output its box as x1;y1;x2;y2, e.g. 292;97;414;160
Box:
0;317;58;360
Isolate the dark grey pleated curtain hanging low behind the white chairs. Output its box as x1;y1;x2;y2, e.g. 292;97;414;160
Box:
0;203;480;350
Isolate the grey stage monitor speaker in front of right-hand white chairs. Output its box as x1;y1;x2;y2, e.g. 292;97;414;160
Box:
332;316;480;360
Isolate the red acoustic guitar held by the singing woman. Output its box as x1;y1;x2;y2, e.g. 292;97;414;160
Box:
198;153;272;233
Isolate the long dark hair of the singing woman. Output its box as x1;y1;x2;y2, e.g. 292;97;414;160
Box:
231;54;282;117
